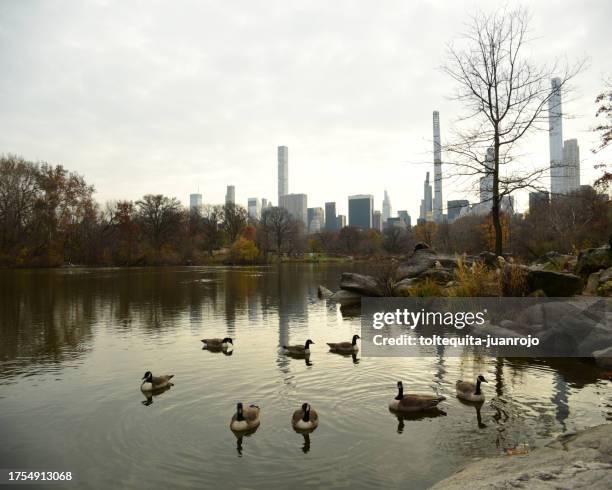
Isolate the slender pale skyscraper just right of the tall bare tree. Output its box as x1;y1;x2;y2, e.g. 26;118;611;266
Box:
548;78;567;198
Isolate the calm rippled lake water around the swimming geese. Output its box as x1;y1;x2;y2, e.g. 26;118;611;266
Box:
0;264;612;489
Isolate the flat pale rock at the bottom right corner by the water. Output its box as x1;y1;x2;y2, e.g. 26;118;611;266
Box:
432;424;612;490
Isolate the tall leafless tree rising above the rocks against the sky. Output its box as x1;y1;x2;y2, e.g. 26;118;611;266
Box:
442;5;584;255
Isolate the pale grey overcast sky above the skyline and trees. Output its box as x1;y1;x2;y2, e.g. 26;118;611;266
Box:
0;0;612;219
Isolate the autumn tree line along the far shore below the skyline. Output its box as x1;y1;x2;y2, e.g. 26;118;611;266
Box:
0;155;612;267
